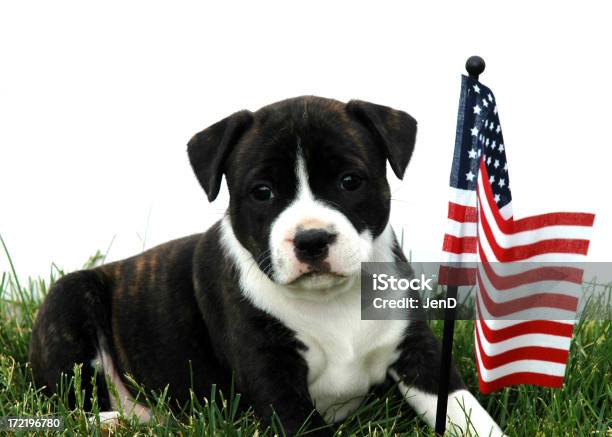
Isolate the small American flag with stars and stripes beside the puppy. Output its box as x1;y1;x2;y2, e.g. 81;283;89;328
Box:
440;76;595;393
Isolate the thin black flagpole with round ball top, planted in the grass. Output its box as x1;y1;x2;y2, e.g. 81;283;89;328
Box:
436;56;485;435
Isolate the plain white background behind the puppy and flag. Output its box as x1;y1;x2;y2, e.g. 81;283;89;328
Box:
0;1;612;275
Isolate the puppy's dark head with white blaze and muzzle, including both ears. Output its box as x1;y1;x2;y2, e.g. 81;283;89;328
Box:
188;97;416;290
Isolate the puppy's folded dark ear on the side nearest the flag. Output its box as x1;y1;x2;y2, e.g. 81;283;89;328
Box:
346;100;417;179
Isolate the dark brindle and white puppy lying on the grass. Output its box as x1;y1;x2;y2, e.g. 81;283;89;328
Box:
30;97;501;435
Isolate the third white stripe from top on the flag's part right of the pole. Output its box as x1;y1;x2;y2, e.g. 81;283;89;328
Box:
478;263;582;303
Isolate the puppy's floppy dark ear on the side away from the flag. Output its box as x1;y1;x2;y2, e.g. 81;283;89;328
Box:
187;111;253;202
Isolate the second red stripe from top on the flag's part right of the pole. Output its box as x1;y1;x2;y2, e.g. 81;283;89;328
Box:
478;201;589;262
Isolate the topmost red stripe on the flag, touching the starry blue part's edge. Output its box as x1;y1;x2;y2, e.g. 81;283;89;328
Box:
480;159;595;234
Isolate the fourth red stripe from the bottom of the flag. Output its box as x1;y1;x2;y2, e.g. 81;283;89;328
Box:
476;271;578;317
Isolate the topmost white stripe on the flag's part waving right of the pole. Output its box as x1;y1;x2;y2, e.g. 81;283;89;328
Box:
478;174;592;244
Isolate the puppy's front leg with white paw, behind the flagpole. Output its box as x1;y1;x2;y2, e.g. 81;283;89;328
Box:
389;321;504;437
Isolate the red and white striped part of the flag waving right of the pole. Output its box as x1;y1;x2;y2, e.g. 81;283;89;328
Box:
475;162;594;393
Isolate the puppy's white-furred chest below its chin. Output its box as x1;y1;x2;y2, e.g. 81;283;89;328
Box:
268;284;408;422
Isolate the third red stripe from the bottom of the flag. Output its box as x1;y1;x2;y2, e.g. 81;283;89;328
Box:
476;299;574;343
